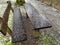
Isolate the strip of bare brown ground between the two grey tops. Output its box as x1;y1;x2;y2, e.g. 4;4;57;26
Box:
22;16;38;45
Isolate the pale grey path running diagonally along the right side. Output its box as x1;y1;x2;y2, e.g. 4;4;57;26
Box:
26;0;60;45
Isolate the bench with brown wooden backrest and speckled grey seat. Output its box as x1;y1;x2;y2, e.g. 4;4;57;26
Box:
0;1;27;42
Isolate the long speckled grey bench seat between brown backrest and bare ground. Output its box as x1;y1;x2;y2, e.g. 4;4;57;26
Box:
12;6;27;43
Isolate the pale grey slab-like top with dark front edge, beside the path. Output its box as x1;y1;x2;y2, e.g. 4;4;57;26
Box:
24;3;51;29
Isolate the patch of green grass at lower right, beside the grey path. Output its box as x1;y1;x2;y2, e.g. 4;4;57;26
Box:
38;33;57;45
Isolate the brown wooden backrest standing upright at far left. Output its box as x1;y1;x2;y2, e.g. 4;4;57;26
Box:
0;1;11;35
